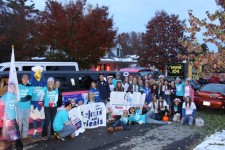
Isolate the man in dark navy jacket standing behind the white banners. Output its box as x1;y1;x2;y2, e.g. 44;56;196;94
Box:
97;73;110;105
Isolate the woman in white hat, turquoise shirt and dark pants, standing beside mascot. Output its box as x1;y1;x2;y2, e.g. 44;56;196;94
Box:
42;77;59;140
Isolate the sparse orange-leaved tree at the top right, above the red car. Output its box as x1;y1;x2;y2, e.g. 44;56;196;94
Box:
182;0;225;72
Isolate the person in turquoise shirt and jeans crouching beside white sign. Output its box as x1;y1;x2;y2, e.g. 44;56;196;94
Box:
53;101;76;141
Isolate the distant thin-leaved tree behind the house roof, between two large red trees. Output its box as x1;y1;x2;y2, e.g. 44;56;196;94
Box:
116;32;141;55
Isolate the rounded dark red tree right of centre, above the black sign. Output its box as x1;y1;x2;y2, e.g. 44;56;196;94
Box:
137;11;187;68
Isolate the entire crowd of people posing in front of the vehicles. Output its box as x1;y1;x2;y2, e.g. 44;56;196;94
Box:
1;72;196;149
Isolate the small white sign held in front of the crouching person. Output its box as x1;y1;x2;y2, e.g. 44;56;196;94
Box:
69;106;85;136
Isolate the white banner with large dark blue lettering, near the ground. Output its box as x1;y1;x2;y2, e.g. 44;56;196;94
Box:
80;102;106;129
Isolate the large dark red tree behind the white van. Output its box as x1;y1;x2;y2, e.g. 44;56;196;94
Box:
39;0;116;69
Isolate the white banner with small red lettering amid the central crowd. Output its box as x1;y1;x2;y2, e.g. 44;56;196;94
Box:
110;91;146;115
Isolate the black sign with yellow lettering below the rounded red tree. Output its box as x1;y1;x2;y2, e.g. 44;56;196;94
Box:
168;63;185;79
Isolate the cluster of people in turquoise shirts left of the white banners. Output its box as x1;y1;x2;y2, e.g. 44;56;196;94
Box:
0;74;75;149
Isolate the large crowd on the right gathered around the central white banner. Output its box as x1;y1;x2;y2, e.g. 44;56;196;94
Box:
78;72;196;133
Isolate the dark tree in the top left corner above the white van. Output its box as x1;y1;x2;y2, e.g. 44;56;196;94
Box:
0;0;40;62
